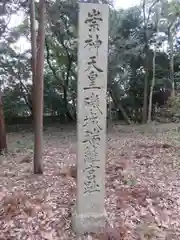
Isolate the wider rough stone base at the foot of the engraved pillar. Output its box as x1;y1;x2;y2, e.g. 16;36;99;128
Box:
72;208;107;235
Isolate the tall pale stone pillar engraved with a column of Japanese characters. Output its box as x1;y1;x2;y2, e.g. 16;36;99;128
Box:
73;3;109;232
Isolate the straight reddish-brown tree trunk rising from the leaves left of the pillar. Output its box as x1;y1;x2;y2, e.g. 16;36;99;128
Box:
33;0;45;174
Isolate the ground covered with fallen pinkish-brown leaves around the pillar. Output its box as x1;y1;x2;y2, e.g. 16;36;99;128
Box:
0;124;180;240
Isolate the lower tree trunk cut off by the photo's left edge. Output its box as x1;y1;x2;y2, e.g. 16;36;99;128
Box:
0;95;7;154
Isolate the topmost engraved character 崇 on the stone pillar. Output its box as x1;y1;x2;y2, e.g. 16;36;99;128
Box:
85;9;103;32
